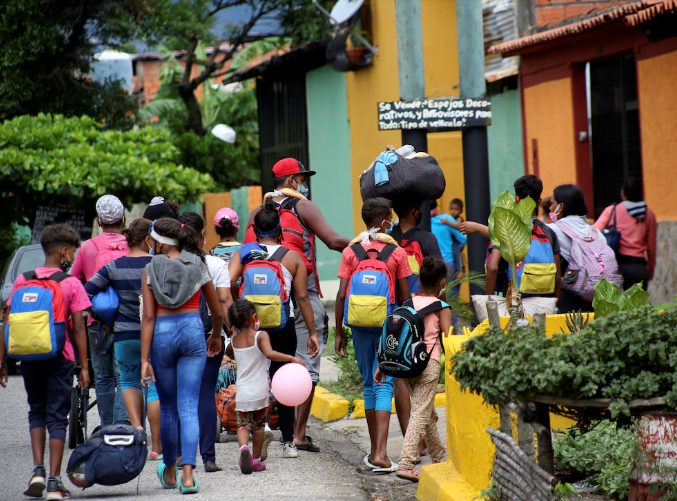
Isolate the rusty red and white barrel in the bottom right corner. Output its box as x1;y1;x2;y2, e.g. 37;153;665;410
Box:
629;412;677;501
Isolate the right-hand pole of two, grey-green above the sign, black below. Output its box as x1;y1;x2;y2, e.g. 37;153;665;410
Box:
456;0;491;294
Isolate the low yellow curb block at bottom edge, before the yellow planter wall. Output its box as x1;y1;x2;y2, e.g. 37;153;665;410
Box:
416;461;480;501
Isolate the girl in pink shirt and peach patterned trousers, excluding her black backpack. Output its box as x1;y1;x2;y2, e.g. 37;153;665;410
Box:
374;257;451;482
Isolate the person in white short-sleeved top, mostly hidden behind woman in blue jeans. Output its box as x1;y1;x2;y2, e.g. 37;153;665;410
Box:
179;212;233;473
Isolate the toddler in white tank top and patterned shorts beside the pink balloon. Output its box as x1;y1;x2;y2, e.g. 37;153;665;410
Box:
226;300;303;475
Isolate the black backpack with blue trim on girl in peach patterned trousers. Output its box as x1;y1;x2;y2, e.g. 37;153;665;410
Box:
377;299;449;379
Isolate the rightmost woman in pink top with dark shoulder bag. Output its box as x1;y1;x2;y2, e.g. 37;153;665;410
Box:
594;177;656;290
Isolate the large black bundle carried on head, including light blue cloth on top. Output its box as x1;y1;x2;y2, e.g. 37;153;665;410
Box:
360;146;446;202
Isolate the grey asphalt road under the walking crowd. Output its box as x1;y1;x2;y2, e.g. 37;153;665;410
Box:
0;376;374;501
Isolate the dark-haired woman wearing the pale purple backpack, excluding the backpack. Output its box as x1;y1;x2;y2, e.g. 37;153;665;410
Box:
548;184;606;313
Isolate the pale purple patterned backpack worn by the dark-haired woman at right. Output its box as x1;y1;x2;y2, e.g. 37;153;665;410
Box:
556;221;623;301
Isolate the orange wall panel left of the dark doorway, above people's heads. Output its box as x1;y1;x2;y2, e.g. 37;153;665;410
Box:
524;78;576;197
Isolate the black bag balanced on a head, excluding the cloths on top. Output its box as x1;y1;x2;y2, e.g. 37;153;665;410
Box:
360;150;447;202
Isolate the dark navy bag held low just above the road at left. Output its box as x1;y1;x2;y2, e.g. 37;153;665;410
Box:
66;388;148;489
